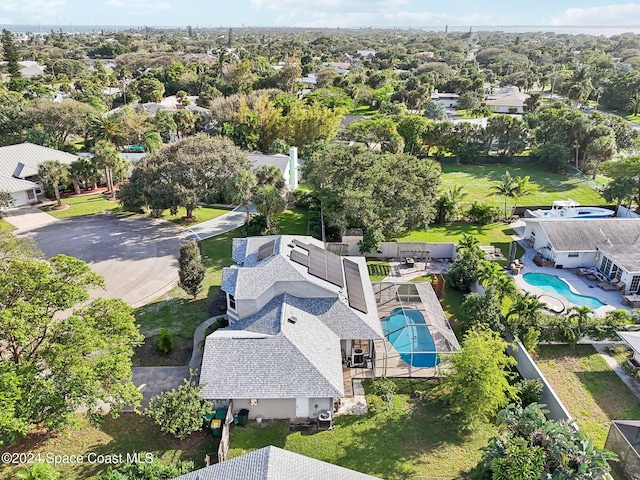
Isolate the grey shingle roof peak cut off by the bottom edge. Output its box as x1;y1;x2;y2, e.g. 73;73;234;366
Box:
174;446;377;480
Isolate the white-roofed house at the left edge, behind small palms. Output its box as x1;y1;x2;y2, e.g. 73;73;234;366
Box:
0;143;78;207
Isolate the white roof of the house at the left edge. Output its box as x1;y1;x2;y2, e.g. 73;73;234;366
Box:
0;143;78;178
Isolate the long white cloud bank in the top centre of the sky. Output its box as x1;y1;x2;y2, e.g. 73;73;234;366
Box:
251;0;495;28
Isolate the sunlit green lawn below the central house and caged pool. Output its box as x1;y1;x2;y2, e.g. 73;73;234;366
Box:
230;380;496;479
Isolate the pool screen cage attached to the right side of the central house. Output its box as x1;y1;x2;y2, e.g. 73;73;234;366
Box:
373;282;460;377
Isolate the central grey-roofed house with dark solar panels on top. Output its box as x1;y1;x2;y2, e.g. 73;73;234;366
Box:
200;235;383;418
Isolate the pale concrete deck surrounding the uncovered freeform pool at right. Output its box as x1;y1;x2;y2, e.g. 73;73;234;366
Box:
511;222;631;316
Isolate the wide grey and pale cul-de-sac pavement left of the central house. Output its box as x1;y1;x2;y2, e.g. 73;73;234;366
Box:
18;214;183;307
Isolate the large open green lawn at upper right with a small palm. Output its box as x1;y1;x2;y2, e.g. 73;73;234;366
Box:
441;165;606;209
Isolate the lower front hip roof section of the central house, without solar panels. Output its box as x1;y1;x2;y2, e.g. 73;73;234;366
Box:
200;295;344;399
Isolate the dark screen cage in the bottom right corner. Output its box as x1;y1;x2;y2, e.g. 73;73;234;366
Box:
604;420;640;480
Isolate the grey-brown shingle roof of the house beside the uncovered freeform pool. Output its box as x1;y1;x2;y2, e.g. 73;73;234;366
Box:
537;218;640;252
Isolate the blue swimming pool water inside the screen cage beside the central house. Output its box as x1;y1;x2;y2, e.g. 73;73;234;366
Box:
382;308;440;367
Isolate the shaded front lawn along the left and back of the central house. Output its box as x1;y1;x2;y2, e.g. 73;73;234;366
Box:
135;209;308;337
